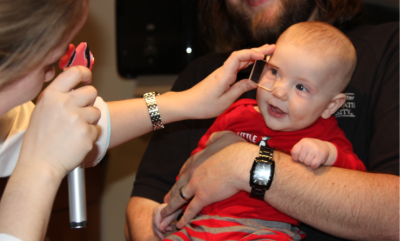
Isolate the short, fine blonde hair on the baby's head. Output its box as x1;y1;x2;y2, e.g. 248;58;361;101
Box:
277;21;357;91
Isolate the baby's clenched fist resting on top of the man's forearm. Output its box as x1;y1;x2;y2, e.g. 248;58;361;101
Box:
290;138;337;169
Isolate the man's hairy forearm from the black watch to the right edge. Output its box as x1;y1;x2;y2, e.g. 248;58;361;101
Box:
265;152;400;240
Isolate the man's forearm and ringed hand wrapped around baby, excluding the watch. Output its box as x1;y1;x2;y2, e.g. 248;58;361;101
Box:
162;133;400;240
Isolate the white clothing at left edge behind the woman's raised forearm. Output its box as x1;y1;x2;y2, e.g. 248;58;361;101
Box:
0;101;35;177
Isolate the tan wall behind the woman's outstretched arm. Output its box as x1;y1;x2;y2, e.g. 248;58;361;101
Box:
73;0;176;241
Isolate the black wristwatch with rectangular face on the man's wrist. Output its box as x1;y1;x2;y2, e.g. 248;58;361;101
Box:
250;146;275;200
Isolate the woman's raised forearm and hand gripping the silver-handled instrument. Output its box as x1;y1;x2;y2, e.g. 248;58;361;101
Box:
0;67;100;240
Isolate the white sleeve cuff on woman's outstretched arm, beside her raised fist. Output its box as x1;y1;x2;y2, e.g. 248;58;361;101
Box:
84;97;111;167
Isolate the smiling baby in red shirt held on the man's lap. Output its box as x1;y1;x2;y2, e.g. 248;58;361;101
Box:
153;22;365;240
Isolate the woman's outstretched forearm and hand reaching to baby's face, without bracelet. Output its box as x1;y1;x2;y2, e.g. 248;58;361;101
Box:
108;45;275;147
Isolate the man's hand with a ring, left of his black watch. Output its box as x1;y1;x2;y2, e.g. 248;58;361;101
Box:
161;131;258;228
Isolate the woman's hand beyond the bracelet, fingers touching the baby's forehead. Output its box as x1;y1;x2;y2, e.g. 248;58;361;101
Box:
181;45;275;119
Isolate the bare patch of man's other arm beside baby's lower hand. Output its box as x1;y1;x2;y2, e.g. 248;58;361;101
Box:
125;197;160;241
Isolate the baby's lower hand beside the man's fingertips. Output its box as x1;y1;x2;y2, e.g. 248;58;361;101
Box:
153;203;182;240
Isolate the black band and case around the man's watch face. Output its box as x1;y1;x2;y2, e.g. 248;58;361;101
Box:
250;146;275;200
